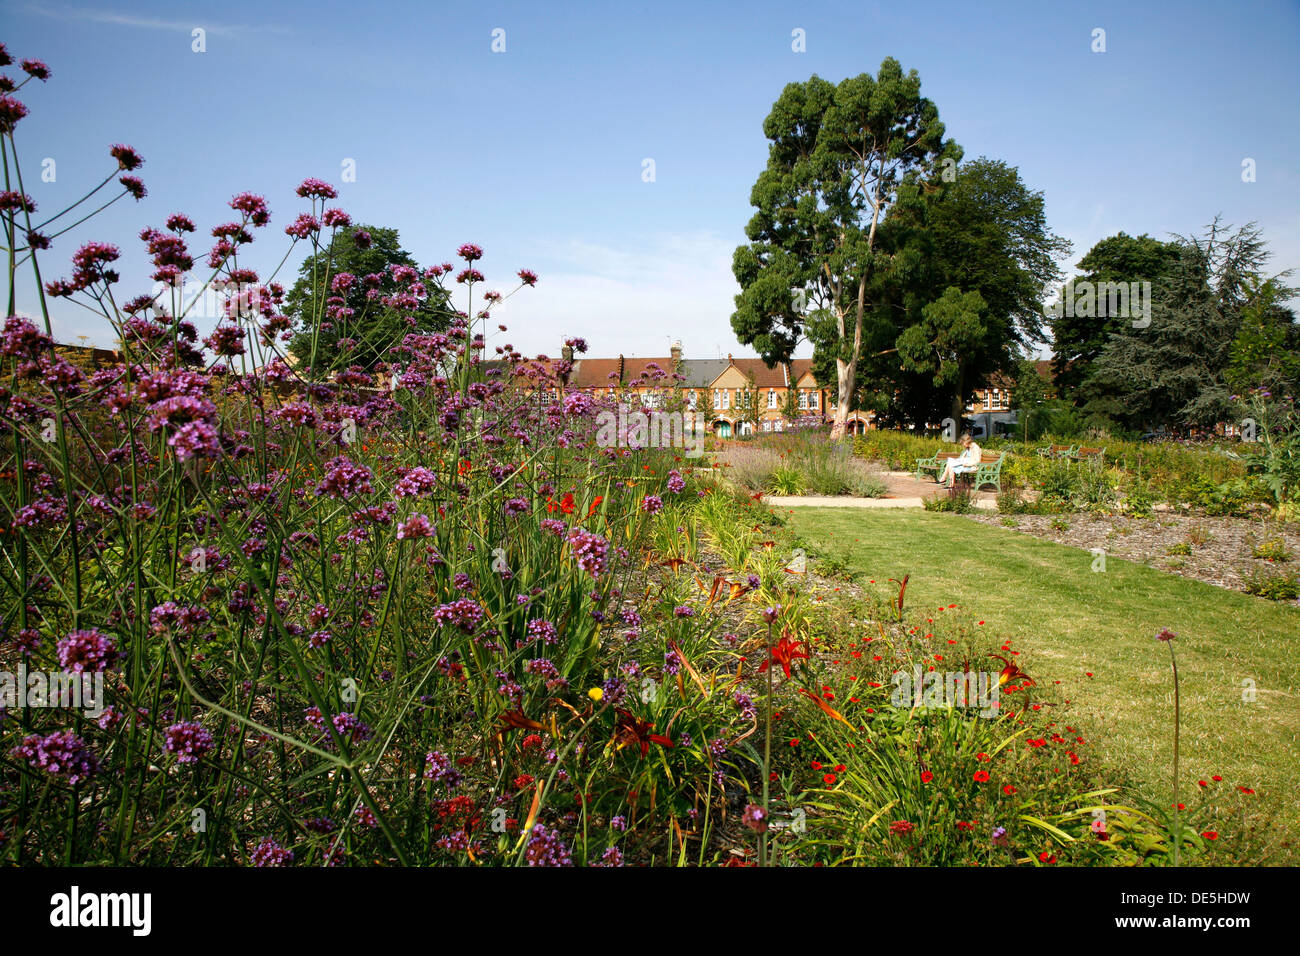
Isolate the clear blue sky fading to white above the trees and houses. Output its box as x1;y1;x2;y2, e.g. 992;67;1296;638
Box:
0;0;1300;358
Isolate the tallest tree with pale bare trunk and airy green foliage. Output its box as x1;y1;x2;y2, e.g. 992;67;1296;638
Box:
732;57;961;437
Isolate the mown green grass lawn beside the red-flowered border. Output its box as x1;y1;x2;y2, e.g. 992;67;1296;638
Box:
784;509;1300;858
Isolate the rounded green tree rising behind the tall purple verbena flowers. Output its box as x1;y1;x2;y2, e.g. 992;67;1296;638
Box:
285;225;451;377
